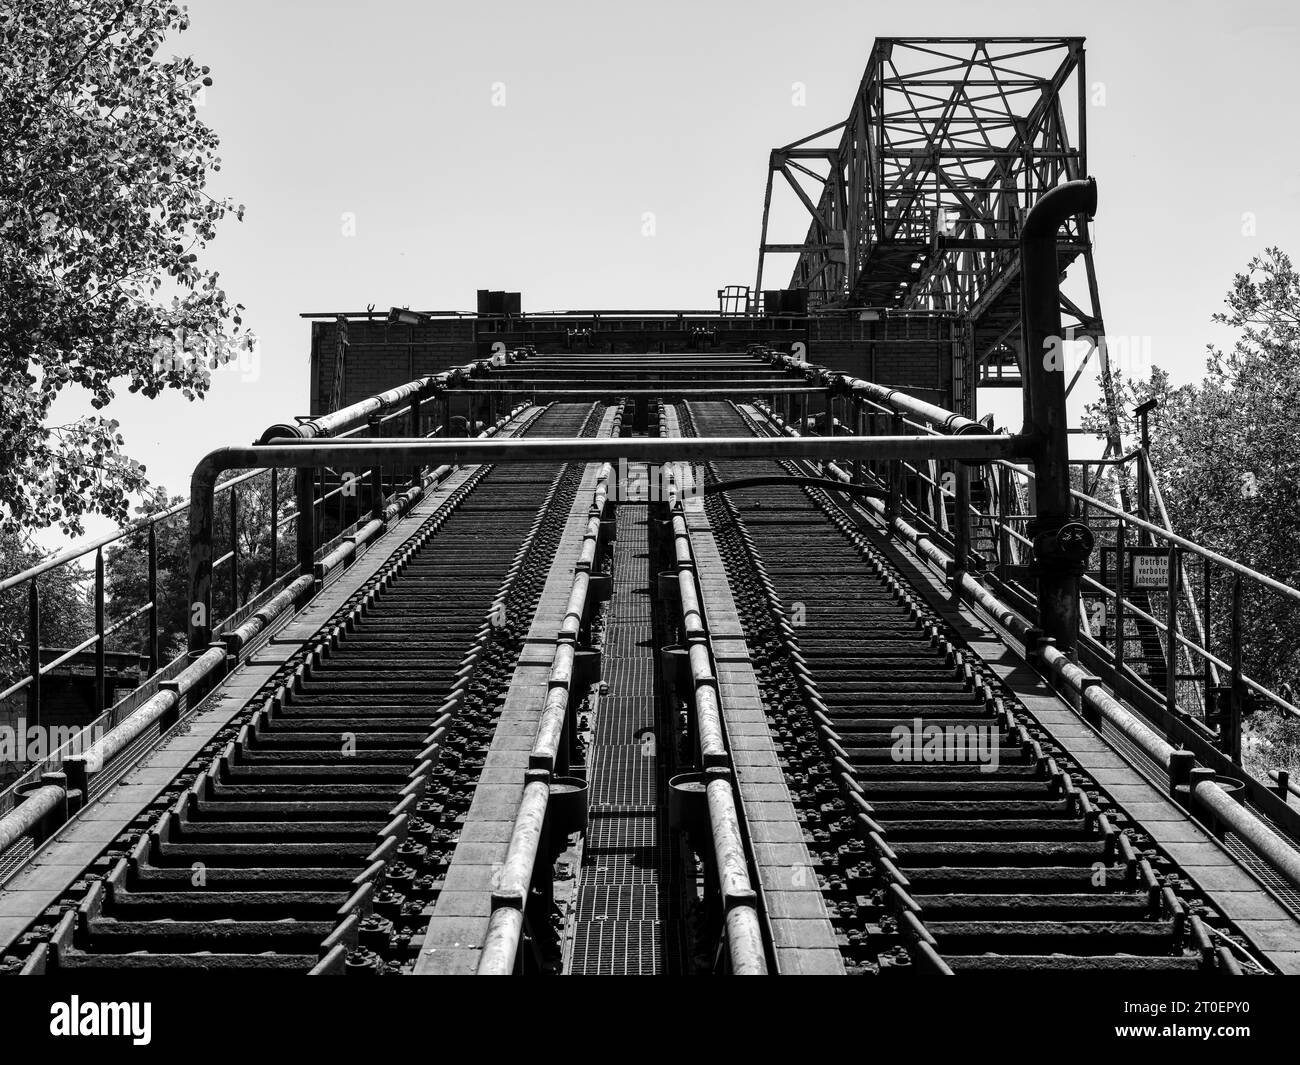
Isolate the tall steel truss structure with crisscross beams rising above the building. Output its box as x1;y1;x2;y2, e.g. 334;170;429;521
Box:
755;36;1119;454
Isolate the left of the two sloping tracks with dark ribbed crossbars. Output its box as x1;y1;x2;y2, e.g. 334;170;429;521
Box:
0;403;602;974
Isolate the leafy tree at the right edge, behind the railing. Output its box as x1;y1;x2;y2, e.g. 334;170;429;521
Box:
1086;247;1300;780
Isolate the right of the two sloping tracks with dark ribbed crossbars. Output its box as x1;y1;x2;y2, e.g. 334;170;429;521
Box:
679;402;1240;974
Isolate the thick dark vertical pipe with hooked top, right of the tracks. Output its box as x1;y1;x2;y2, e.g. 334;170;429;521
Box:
1021;178;1097;654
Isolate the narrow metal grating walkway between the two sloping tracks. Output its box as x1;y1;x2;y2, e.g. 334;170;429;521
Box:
569;488;677;975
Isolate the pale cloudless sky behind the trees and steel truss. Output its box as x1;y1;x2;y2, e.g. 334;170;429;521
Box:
35;0;1300;546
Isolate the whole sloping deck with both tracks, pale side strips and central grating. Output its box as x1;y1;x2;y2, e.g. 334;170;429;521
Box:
0;355;1300;974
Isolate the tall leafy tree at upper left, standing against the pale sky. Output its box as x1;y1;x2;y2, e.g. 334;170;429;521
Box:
0;0;255;534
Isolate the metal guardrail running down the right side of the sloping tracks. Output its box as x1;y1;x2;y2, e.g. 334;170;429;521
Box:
761;352;1300;835
